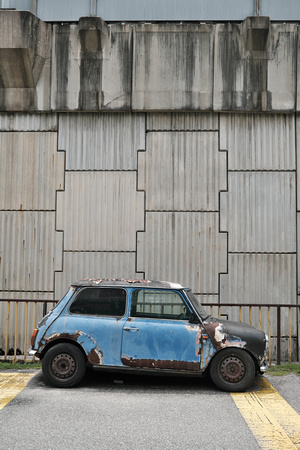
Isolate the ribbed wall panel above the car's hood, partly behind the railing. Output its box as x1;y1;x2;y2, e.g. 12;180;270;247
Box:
220;254;297;335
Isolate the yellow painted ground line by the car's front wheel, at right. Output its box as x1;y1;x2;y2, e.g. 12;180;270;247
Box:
231;377;300;450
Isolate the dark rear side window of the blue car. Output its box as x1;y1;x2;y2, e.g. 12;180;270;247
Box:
69;287;126;317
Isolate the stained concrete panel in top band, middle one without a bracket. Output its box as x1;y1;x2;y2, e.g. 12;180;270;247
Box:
132;24;213;111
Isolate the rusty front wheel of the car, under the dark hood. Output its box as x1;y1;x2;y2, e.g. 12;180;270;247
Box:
210;348;255;392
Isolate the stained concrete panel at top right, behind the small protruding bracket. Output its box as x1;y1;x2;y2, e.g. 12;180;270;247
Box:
213;17;296;111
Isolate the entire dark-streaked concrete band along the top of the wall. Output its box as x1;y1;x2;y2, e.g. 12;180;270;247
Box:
0;11;299;112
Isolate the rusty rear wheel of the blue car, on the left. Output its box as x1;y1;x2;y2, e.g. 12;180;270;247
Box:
42;344;86;387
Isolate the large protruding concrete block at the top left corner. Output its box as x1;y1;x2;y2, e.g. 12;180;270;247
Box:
0;11;51;111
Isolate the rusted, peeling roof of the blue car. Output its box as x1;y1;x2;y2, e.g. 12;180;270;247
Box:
72;278;185;289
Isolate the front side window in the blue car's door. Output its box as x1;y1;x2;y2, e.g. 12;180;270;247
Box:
130;289;191;320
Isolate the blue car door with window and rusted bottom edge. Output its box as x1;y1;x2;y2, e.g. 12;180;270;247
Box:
121;289;201;371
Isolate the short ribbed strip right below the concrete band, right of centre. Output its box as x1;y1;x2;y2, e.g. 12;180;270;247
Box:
147;113;219;131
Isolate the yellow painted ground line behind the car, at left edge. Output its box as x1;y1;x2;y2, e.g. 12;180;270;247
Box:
0;373;35;410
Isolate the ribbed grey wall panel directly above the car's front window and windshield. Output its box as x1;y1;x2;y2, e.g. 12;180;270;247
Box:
137;212;227;294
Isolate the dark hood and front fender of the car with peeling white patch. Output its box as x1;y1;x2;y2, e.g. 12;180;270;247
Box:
203;317;266;358
